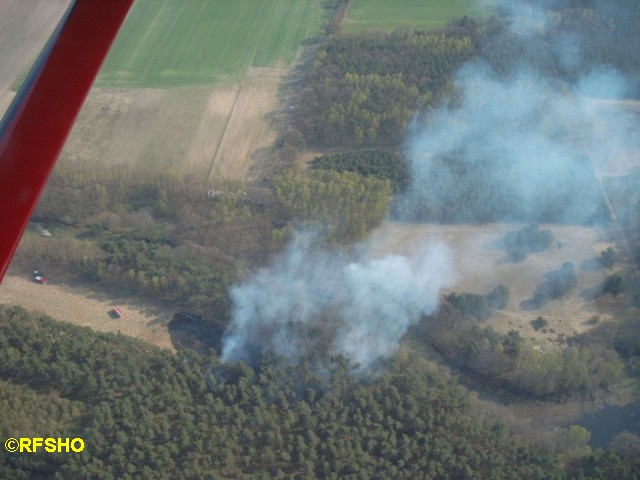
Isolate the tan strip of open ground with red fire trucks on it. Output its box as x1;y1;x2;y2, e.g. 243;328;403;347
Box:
0;274;173;350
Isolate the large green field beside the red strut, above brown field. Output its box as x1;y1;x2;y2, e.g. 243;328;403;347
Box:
98;0;327;87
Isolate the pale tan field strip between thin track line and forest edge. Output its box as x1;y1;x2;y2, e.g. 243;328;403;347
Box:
209;69;286;182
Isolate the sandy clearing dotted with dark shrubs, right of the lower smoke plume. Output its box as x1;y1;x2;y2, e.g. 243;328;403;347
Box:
372;222;616;346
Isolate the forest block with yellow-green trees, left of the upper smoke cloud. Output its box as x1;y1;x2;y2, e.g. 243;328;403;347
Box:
295;31;474;147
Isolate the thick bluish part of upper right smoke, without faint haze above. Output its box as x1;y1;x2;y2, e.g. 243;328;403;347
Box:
399;64;637;224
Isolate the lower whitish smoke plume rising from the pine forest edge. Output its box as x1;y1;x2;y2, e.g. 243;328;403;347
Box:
222;234;454;368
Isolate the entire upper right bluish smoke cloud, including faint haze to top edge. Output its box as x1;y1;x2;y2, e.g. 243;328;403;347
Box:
396;0;640;224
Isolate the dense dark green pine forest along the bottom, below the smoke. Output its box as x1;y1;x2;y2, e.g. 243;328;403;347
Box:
0;307;640;480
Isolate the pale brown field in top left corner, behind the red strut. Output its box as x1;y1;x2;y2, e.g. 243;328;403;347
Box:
0;0;71;98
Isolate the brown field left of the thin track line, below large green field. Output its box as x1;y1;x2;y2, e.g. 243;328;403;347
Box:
59;87;238;174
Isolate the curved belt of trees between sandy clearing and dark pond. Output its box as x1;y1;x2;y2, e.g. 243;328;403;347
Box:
416;289;640;398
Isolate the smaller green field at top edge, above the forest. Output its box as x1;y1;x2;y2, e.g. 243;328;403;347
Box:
343;0;495;32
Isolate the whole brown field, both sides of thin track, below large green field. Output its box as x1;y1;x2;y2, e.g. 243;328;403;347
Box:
59;69;284;184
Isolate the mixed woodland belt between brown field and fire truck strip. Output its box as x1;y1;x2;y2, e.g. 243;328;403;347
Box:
16;166;391;320
